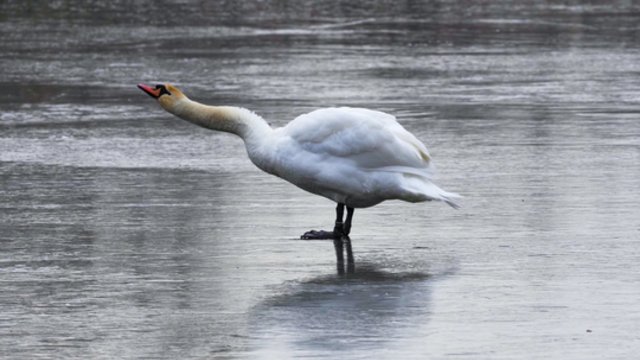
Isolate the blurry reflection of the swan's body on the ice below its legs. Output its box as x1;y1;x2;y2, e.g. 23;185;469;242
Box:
250;263;430;357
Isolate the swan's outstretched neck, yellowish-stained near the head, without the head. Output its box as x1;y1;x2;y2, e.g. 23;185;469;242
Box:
165;97;273;147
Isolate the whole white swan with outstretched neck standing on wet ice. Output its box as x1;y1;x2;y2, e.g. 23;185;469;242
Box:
138;84;459;239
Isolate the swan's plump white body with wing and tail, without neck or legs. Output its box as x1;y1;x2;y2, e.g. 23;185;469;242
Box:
252;107;456;208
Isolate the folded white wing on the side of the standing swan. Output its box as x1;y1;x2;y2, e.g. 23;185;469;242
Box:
282;108;432;177
